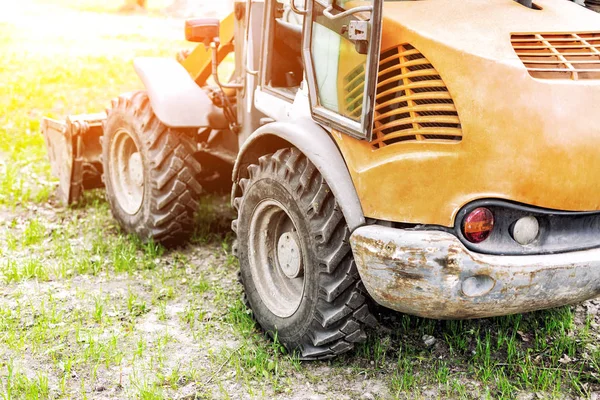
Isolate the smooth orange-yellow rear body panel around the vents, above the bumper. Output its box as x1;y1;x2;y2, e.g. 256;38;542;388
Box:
334;0;600;226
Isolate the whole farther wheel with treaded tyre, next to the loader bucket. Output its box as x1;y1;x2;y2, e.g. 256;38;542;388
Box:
102;91;202;246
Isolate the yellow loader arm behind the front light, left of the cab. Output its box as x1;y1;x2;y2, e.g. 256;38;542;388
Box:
181;13;235;85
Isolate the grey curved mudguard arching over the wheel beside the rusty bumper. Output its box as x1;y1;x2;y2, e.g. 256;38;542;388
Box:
231;117;365;232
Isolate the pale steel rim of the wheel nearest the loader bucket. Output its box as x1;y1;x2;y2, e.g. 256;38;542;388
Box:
110;129;144;215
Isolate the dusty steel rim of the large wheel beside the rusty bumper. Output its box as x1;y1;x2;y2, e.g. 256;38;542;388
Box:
248;200;305;318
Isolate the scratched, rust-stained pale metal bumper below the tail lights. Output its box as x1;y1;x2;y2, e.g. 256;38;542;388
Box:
350;225;600;319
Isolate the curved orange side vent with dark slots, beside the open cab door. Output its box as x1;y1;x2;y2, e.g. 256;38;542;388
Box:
372;44;462;149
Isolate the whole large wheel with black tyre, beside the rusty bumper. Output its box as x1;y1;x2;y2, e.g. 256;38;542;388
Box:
233;148;376;360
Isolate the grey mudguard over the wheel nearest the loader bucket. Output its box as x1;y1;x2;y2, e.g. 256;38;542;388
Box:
133;57;215;128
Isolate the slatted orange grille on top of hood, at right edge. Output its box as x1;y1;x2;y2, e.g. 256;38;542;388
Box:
511;32;600;80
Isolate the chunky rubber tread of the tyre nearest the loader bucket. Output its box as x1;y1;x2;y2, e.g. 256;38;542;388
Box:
103;91;202;246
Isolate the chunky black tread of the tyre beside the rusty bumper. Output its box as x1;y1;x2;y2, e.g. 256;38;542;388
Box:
232;148;376;360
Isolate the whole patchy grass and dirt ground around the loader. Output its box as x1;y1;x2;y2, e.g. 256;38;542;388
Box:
0;0;600;399
